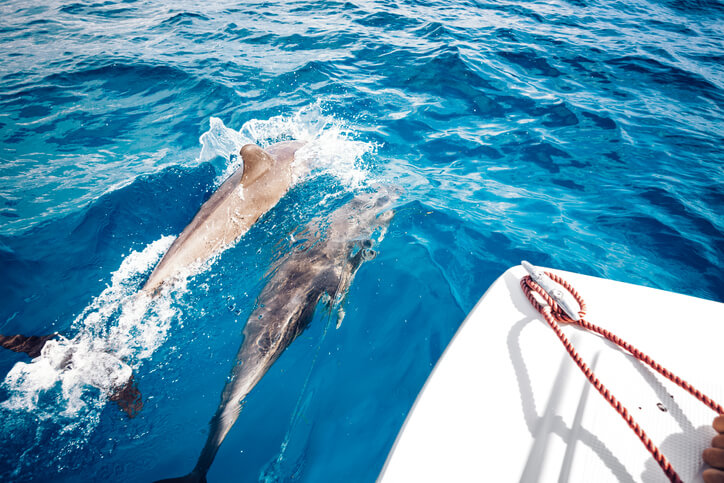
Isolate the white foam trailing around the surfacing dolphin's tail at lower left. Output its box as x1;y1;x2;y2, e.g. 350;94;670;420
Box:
2;236;183;420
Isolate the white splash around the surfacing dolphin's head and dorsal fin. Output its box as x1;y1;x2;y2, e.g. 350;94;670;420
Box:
198;103;377;189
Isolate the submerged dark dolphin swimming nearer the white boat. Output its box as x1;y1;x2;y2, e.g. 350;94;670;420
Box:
157;189;396;483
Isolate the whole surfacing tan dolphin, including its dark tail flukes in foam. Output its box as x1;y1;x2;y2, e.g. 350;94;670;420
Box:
0;141;305;417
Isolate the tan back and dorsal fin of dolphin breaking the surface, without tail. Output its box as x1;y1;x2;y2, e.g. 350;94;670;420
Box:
143;141;304;295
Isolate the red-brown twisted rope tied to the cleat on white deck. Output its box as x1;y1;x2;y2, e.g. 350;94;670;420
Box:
520;272;724;483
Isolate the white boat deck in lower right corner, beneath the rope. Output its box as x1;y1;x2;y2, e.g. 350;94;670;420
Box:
380;266;724;483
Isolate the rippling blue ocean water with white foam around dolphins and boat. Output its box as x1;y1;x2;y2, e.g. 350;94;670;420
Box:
0;0;724;482
